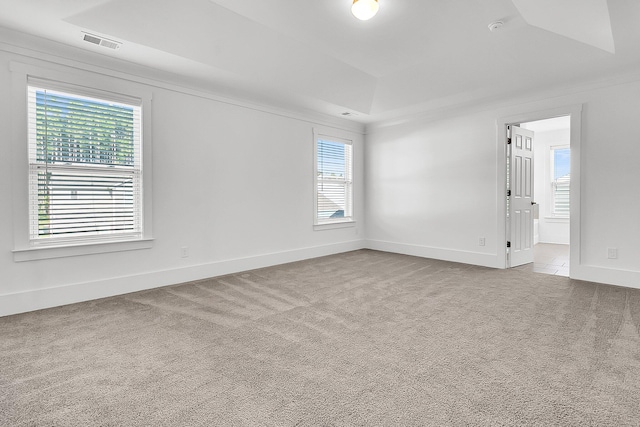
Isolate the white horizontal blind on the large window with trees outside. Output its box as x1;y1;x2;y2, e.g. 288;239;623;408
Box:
28;81;142;245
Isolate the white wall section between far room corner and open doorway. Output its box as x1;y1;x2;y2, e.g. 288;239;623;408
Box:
365;113;499;267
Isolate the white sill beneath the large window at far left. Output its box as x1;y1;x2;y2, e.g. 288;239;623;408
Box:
13;239;153;262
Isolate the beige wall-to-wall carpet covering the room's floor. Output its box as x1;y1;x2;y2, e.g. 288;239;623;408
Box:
0;250;640;426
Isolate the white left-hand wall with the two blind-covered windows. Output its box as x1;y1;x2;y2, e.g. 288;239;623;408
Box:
0;40;364;315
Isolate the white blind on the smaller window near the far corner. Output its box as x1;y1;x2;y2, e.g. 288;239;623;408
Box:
316;137;353;224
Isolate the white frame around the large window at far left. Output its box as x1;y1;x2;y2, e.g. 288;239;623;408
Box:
10;62;153;262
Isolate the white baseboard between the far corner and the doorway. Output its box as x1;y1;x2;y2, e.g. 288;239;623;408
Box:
366;240;504;268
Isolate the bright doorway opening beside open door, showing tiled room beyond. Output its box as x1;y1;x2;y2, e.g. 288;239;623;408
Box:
507;115;571;277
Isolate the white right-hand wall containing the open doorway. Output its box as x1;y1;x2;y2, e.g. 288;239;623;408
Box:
365;80;640;287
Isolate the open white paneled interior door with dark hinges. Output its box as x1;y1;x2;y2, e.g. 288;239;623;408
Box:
508;126;535;267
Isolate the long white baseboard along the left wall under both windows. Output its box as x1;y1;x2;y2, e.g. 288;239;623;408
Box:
0;240;365;317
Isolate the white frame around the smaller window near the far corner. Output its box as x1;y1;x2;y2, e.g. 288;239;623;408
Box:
313;129;355;230
